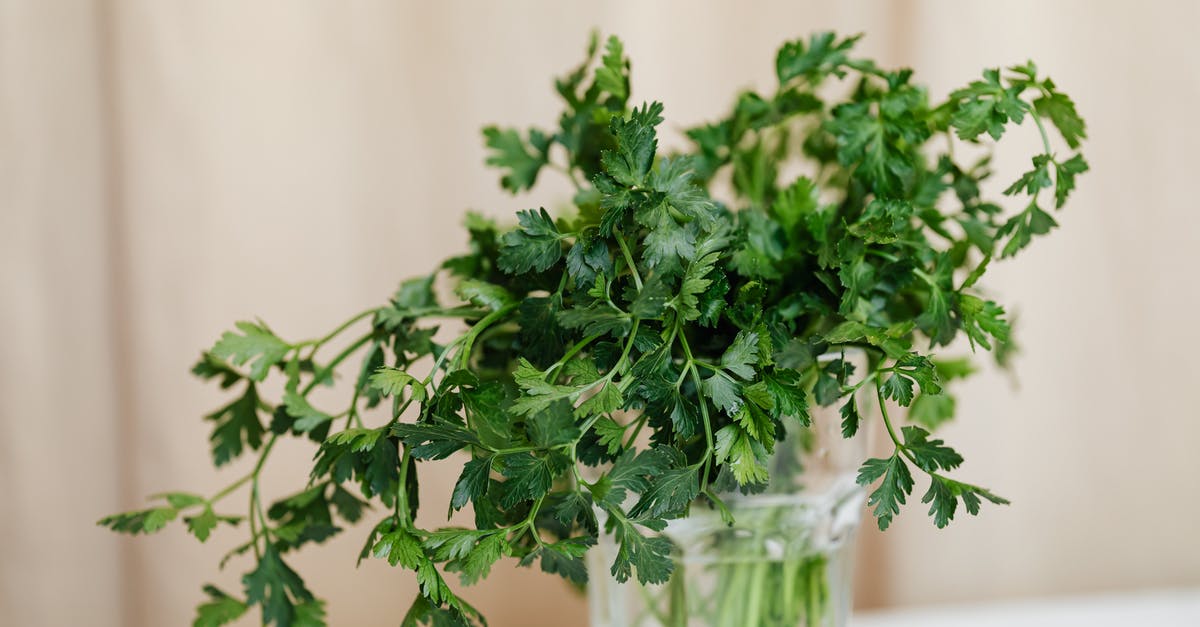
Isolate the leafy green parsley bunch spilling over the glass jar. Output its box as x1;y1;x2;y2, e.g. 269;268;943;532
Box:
101;34;1087;626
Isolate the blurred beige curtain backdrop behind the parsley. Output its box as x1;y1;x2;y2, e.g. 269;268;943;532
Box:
0;0;1200;627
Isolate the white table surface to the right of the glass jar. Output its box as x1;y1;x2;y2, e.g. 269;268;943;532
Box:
850;589;1200;627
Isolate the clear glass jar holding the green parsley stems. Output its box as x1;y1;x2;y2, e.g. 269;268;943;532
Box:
588;351;874;627
